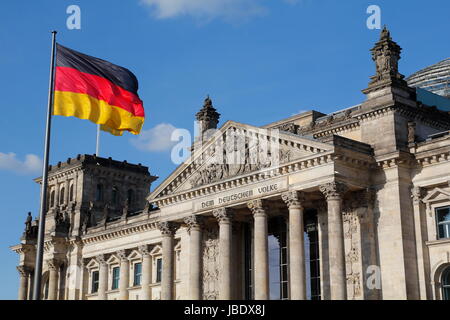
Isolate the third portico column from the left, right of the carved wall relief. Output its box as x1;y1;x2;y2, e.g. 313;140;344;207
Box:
213;208;233;300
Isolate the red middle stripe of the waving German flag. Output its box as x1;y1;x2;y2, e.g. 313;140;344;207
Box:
55;67;145;117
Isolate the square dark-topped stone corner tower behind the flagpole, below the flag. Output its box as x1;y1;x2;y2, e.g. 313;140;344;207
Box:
35;155;156;237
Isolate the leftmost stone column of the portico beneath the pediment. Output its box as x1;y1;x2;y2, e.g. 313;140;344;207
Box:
158;221;177;300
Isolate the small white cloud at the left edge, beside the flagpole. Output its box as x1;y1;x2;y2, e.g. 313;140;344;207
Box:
0;152;43;174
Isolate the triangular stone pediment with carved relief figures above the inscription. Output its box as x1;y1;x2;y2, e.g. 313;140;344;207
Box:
148;121;333;202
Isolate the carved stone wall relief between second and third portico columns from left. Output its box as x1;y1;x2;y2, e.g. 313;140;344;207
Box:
202;227;219;300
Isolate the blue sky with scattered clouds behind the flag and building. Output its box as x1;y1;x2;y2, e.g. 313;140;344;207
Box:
0;0;450;299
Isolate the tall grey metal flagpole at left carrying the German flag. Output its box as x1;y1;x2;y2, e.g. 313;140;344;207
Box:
33;31;57;300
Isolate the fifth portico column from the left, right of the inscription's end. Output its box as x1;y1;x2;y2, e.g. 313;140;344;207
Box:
281;191;306;300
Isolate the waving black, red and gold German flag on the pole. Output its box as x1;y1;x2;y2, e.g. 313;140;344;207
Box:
53;44;145;135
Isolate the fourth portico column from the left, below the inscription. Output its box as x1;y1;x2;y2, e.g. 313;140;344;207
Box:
247;200;269;300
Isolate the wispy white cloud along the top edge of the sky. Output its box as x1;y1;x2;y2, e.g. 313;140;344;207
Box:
141;0;268;21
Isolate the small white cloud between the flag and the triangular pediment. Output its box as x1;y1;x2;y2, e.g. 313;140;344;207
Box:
131;123;177;152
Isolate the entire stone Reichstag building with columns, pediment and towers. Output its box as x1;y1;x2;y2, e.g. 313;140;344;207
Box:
12;29;450;300
